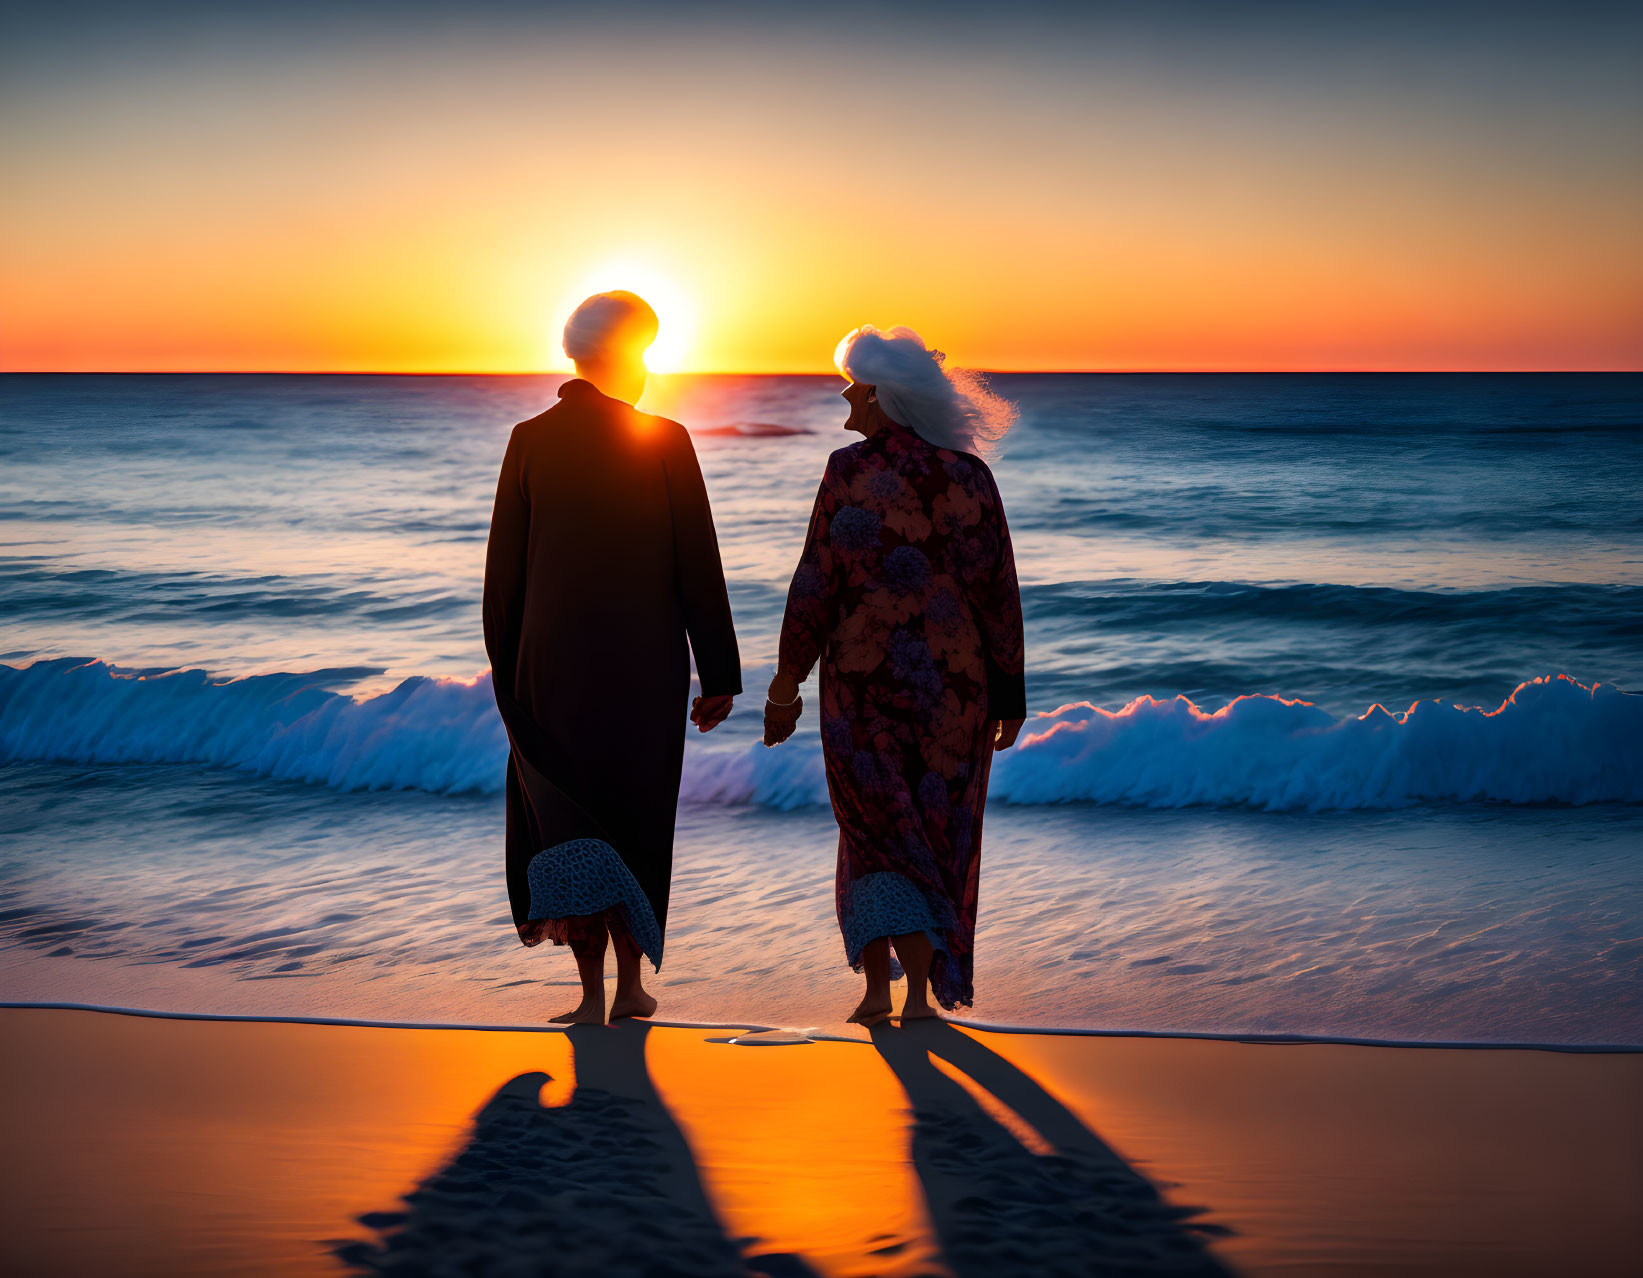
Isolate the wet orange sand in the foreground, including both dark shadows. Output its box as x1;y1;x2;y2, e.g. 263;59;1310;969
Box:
0;1009;1643;1278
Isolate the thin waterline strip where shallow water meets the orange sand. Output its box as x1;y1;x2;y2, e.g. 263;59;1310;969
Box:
0;1000;1643;1056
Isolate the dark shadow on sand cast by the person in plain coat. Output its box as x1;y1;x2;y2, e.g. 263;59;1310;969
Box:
334;1022;810;1278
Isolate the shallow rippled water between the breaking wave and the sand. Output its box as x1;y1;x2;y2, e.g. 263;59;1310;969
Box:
0;764;1643;1046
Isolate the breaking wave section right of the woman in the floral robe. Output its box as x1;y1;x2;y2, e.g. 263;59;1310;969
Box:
992;675;1643;811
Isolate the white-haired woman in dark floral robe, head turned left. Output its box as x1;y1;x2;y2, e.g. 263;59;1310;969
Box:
764;327;1027;1025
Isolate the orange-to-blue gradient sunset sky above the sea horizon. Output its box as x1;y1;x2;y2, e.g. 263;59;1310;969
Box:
0;0;1643;371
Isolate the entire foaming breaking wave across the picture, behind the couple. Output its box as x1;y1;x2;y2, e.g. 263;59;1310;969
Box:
0;660;1643;810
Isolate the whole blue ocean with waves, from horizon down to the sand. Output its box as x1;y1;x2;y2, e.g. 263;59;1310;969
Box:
0;375;1643;1045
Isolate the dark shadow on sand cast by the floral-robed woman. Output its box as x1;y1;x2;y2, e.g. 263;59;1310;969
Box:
872;1020;1227;1278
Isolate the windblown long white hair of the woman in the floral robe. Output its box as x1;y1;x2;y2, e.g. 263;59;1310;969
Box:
833;324;1015;457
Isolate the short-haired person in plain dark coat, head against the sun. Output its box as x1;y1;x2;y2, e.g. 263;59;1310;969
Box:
485;292;741;1022
